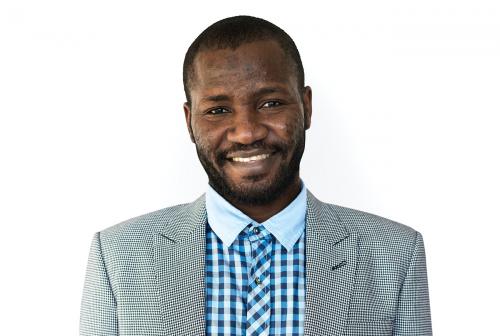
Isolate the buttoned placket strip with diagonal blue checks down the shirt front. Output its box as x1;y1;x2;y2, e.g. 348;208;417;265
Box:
247;228;272;336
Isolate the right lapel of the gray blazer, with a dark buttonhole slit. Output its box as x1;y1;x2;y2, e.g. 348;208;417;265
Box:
304;193;357;336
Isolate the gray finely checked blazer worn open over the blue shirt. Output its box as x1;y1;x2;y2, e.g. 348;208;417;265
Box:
80;193;432;336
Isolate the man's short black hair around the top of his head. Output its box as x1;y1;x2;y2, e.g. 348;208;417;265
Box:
183;15;304;104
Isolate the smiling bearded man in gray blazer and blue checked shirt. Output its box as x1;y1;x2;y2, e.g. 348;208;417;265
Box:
80;16;432;335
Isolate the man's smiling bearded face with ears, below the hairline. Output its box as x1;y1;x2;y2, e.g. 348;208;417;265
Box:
184;41;311;204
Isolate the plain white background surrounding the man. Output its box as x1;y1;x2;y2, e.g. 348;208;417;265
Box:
0;0;500;335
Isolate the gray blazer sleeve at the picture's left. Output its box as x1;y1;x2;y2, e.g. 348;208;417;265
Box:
80;233;119;336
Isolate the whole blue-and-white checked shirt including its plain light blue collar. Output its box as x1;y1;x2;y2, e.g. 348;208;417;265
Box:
206;184;307;336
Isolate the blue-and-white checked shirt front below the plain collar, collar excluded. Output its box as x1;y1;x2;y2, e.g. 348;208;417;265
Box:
206;224;305;336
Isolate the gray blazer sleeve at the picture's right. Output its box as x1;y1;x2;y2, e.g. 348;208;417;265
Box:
394;232;432;336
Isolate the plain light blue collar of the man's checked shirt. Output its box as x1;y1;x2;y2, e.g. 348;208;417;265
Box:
205;183;307;252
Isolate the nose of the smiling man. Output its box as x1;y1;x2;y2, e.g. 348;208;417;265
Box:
227;107;268;145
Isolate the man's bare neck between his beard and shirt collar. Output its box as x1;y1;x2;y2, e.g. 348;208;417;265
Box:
231;177;301;223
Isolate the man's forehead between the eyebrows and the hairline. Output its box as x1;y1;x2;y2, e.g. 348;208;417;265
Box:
191;41;296;91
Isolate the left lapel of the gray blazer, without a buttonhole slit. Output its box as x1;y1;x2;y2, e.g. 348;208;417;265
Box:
153;196;207;335
